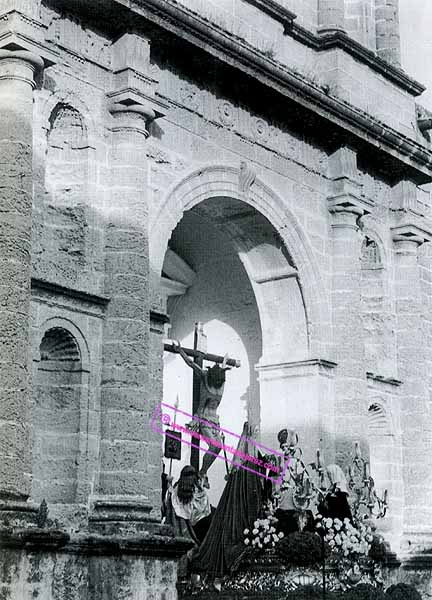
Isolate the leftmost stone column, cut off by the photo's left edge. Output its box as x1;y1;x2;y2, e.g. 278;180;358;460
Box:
0;50;43;502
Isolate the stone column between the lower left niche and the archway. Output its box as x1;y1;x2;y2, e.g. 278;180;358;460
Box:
95;103;162;521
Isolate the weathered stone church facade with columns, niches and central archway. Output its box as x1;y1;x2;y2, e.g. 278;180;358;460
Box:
0;0;432;600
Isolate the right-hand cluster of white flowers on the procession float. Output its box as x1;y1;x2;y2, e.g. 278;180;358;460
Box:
317;515;373;559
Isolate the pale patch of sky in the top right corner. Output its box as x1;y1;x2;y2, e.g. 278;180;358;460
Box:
399;0;432;110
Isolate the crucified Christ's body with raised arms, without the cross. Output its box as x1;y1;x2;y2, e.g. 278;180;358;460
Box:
175;341;230;488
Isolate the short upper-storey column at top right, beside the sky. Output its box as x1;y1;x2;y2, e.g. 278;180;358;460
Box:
375;0;401;66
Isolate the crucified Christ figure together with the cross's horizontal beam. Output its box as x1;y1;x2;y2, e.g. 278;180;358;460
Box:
165;330;240;487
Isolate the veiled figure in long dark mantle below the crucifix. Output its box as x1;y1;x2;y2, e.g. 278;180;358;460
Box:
191;423;264;579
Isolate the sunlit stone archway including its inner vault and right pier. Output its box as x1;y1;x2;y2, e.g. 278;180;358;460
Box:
150;166;333;472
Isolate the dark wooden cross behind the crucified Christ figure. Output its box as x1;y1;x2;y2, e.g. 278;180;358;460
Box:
164;323;240;471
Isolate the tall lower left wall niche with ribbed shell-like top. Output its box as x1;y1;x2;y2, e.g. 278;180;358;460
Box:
32;327;83;504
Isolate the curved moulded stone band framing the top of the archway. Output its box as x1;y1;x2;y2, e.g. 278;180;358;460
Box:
149;165;332;359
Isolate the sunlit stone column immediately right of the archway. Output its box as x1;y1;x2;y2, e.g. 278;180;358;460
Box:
328;147;370;465
